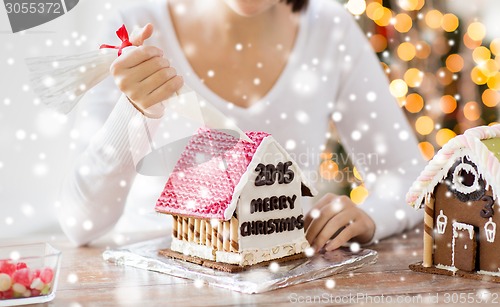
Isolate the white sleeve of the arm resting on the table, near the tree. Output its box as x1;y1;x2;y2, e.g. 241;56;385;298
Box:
333;11;423;242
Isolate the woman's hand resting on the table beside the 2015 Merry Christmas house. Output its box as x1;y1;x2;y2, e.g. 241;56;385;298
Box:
305;193;375;252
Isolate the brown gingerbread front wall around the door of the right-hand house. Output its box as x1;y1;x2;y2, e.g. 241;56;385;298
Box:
433;183;500;273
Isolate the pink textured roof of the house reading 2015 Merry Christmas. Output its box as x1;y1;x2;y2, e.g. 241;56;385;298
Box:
156;129;270;220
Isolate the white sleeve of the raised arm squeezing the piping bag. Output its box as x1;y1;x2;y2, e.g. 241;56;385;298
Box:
59;92;148;245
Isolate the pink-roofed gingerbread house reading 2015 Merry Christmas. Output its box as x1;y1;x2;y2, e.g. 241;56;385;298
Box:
156;129;315;266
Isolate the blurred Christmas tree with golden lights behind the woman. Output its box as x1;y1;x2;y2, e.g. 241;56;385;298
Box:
320;0;500;203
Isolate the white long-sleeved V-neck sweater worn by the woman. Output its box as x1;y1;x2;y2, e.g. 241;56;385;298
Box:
59;0;423;245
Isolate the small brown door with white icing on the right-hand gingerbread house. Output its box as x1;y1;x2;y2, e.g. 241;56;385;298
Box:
452;222;477;272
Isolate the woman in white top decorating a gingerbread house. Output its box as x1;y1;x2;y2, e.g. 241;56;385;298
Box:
60;0;421;250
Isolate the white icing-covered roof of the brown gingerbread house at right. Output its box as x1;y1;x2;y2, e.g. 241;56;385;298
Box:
406;125;500;209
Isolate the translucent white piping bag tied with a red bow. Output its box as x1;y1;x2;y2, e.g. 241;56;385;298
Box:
26;25;253;176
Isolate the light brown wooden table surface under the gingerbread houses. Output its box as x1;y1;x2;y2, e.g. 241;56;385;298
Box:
2;227;500;307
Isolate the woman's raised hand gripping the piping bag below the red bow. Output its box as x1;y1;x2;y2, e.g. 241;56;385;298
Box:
111;24;184;115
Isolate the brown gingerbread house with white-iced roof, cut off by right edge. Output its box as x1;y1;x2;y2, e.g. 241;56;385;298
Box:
407;125;500;282
